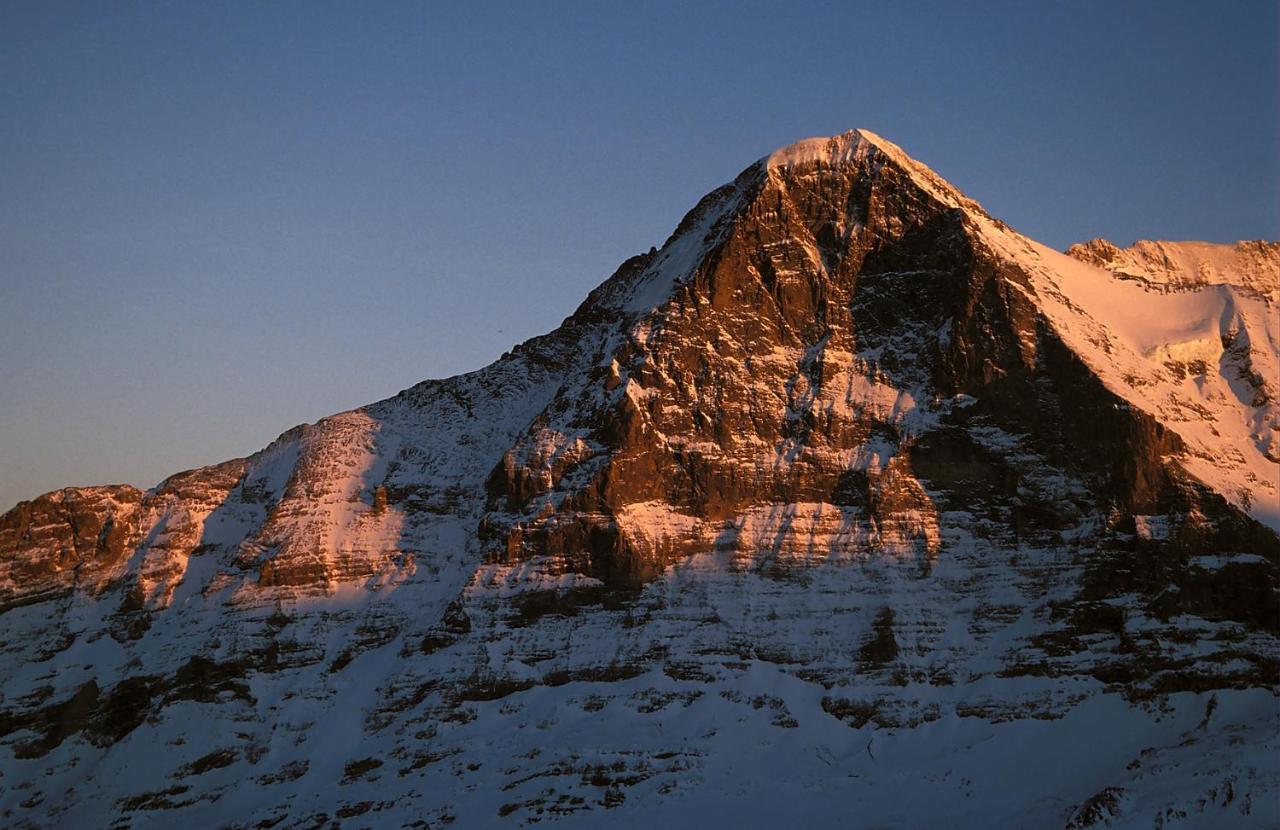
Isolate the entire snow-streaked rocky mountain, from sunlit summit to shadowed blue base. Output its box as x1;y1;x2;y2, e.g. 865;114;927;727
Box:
0;131;1280;827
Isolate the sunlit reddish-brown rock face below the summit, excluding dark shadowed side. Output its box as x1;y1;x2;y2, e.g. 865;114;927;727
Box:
486;136;966;579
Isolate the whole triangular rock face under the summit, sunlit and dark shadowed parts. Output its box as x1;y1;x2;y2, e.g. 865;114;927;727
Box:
486;133;1274;580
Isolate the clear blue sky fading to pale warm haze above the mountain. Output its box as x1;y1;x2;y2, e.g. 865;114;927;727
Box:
0;0;1280;510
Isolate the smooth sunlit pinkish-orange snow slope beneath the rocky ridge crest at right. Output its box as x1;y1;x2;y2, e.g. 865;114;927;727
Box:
1034;239;1280;530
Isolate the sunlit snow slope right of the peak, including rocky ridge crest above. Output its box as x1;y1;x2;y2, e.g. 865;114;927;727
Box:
957;223;1280;530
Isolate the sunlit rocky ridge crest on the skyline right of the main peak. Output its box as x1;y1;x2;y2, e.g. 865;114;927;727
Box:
1066;240;1280;302
